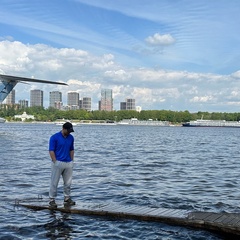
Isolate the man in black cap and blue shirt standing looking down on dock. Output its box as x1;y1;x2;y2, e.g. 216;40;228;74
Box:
49;122;75;208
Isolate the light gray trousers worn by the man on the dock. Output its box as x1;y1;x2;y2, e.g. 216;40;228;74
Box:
49;161;73;198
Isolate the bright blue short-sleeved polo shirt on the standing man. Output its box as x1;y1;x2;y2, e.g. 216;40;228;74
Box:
49;131;74;162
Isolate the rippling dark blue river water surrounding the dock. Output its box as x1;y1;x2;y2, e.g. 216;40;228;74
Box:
0;123;240;240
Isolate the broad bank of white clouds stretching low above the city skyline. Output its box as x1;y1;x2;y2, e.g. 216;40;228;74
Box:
0;41;240;111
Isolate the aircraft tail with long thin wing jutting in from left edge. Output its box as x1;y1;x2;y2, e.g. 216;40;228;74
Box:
0;74;67;123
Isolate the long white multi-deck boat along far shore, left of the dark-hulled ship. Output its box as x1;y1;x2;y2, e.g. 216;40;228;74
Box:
117;118;170;127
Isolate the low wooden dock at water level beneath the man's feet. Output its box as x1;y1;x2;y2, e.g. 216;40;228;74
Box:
15;199;240;236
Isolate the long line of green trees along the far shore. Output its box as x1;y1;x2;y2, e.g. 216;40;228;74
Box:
0;104;240;123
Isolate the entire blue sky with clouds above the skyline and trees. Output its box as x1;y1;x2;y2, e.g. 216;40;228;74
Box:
0;0;240;112
